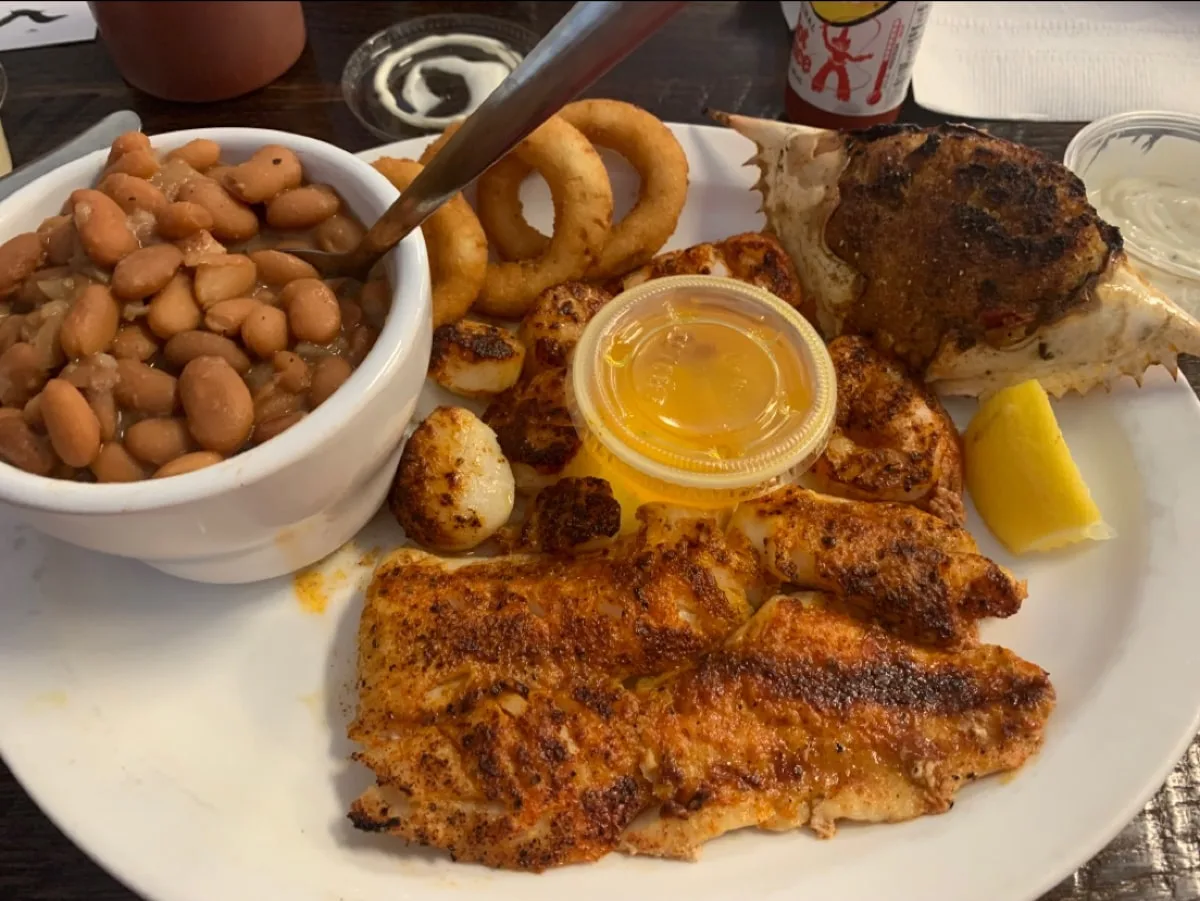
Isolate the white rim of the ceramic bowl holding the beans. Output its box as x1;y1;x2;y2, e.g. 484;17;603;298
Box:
0;126;431;515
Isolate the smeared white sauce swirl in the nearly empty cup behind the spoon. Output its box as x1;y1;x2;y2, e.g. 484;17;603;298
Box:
374;35;522;128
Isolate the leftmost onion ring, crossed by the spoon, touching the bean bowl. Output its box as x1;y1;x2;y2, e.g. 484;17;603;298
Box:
374;157;487;329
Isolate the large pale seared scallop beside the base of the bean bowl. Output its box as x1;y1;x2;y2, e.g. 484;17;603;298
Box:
388;407;516;551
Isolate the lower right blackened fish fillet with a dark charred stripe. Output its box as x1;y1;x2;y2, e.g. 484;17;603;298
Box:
620;595;1055;859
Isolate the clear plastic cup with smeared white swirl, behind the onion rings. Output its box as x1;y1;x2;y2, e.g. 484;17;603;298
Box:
342;14;540;140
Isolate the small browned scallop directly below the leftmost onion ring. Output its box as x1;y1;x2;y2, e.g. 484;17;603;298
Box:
430;319;526;397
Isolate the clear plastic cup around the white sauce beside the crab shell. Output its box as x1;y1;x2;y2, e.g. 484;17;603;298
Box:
1063;110;1200;316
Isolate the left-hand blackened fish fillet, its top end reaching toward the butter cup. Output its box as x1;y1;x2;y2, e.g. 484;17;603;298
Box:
349;506;758;870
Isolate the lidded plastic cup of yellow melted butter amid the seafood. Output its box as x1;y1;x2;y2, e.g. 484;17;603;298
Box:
569;276;836;507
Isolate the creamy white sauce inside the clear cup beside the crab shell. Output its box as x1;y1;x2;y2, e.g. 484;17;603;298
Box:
1087;176;1200;269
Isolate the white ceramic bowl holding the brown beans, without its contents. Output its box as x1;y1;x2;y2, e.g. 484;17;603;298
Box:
0;128;432;583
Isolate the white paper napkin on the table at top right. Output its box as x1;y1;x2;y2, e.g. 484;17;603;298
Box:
913;0;1200;121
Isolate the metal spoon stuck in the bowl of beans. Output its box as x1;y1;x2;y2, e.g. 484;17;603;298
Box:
289;2;685;280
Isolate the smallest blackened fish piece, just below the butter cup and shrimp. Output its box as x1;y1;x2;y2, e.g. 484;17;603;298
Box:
730;486;1026;648
